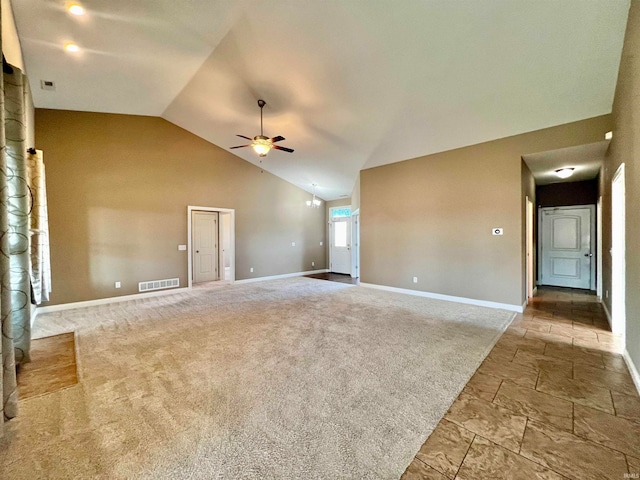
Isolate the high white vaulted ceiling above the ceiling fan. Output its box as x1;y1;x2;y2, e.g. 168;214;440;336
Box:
13;0;629;200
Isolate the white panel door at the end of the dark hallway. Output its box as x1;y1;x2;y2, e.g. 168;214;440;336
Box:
540;207;593;289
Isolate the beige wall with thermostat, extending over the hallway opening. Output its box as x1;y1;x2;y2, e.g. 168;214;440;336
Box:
360;113;611;305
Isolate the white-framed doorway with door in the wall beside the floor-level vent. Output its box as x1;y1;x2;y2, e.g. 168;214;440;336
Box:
187;205;236;287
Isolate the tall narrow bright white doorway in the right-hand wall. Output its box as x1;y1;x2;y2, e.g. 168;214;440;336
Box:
611;163;626;335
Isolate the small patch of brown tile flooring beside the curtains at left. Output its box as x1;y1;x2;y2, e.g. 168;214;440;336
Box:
18;332;78;400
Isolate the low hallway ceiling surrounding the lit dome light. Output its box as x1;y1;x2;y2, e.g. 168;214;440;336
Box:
522;140;609;185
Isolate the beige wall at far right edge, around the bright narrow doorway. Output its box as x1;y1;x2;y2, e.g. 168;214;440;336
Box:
601;0;640;368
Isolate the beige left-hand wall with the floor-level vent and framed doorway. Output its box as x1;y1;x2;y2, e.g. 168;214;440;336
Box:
36;109;326;304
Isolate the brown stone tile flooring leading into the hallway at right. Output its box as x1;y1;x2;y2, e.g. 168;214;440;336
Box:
402;288;640;480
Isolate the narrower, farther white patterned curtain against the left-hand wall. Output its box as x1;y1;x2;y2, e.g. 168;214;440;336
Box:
27;149;51;305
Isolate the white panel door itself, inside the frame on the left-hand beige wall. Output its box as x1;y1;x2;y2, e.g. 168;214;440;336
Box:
192;212;218;283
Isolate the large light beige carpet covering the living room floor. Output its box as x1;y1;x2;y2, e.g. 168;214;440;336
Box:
0;278;513;479
